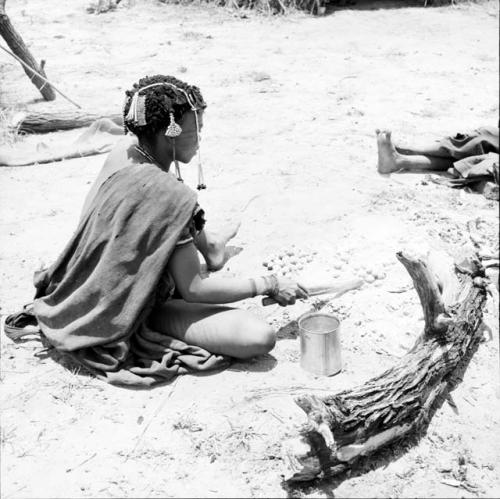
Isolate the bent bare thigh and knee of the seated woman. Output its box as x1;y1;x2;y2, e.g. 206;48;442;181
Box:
148;299;276;359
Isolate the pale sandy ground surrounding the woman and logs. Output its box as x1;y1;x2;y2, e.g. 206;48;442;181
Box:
0;0;500;499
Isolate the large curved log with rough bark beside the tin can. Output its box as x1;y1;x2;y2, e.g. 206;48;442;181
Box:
285;252;486;481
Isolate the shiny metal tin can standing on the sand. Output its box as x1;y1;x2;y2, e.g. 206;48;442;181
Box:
298;312;342;376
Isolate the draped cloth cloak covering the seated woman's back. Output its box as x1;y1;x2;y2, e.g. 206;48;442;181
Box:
33;163;228;386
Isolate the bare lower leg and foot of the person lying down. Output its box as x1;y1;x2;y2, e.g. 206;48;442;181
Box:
377;130;454;173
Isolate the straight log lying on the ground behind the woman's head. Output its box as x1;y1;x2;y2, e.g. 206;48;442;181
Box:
11;111;123;133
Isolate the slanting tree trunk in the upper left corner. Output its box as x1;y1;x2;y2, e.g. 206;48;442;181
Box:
0;0;56;101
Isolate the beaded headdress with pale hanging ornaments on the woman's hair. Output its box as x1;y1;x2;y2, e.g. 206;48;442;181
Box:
124;81;207;190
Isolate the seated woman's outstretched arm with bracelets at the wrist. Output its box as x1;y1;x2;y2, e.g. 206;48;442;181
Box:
167;243;308;306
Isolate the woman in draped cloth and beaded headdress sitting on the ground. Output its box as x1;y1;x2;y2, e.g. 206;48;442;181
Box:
10;75;307;386
